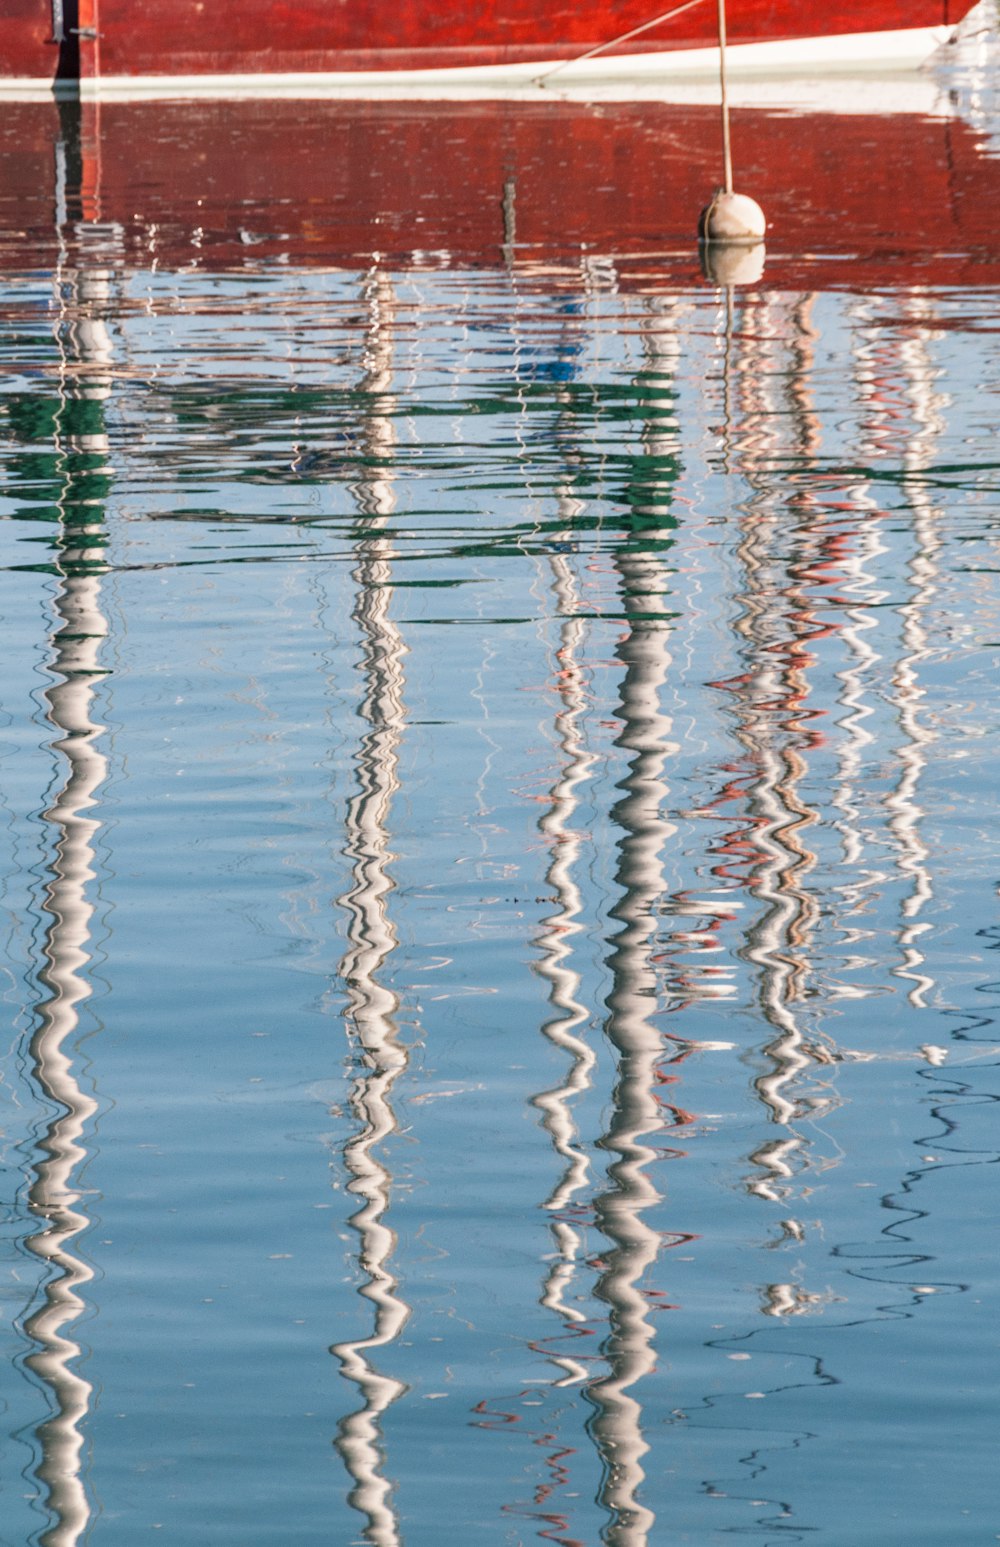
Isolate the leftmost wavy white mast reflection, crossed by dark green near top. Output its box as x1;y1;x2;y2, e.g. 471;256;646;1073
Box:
25;215;113;1547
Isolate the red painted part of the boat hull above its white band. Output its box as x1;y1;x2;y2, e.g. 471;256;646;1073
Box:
0;0;971;79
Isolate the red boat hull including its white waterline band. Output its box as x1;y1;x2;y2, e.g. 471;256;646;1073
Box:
0;0;971;96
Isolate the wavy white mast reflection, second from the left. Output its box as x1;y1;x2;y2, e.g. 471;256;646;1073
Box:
331;268;410;1547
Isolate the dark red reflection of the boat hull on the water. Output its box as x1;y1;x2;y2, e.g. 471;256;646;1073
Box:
0;101;1000;291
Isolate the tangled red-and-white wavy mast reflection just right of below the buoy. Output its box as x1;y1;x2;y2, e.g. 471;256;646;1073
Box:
712;295;842;1280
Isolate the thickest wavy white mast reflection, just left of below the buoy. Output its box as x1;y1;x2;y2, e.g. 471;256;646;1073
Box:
587;302;678;1547
